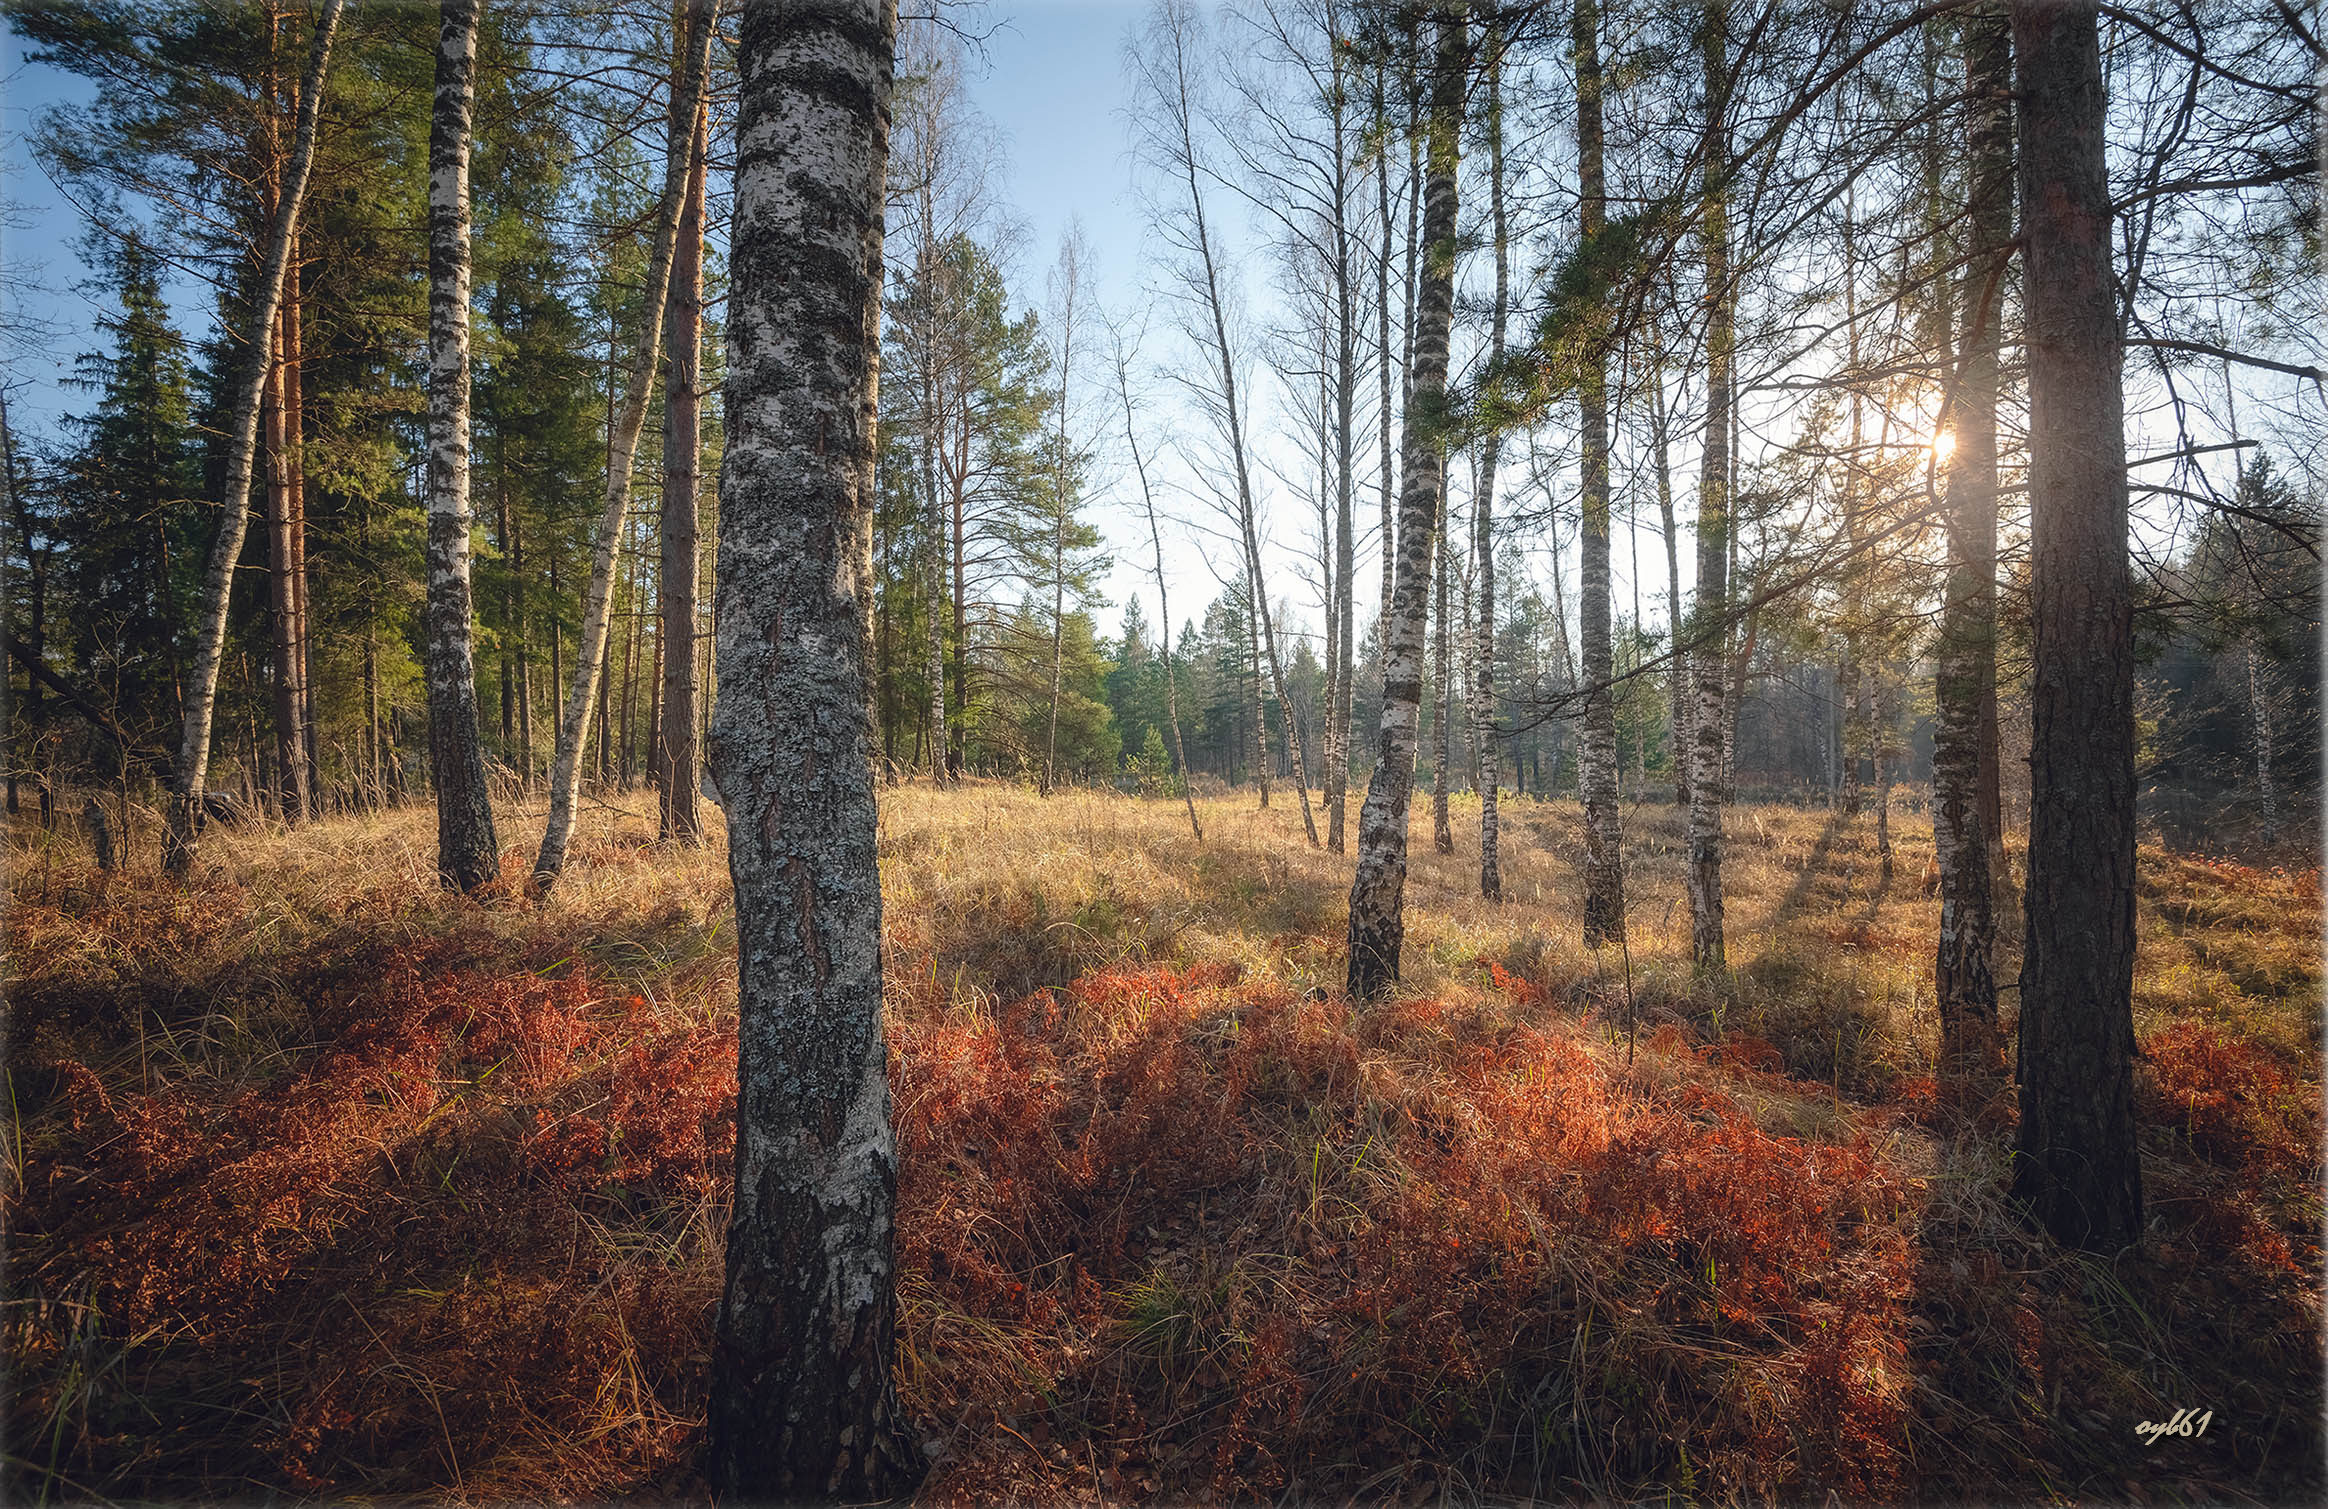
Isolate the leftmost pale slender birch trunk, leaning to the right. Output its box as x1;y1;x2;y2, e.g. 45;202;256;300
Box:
163;0;347;876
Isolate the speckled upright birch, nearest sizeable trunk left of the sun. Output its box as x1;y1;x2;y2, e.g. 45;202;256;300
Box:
1690;0;1734;973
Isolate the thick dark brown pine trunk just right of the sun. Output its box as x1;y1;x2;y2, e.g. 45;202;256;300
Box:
2011;0;2142;1251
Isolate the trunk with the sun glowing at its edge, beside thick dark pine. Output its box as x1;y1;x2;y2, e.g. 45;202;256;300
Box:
1932;5;2014;1069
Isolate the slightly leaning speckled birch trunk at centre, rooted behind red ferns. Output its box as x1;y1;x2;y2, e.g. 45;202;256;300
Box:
1348;0;1467;1001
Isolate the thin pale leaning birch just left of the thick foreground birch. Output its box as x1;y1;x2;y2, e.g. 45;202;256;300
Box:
533;2;726;894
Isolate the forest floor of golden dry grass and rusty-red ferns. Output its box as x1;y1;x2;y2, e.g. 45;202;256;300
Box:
5;785;2323;1504
